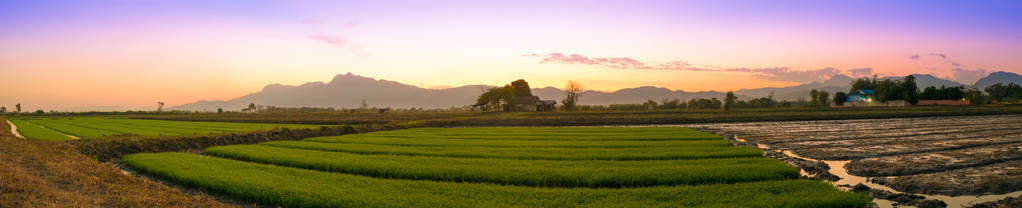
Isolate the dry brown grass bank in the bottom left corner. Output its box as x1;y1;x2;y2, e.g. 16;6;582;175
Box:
0;118;231;207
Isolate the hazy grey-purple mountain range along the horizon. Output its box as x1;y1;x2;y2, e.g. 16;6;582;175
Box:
170;71;1022;111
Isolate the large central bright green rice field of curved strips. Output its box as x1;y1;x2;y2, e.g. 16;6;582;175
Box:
124;127;871;207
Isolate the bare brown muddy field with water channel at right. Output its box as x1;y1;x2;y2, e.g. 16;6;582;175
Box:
687;115;1022;207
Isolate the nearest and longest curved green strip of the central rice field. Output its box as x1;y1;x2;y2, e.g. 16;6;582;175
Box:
124;153;871;208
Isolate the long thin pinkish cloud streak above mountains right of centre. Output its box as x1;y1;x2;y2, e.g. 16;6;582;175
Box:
522;53;858;83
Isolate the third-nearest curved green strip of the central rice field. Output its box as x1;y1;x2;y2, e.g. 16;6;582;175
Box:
261;141;762;160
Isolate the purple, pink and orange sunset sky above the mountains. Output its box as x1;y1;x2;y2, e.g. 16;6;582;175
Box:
0;0;1022;110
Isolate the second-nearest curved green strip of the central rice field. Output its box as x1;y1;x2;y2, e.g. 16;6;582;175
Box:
205;145;798;188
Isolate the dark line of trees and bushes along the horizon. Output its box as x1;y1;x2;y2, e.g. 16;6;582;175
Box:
6;75;1022;115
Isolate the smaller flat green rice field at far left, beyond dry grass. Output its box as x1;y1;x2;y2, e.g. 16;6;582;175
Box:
10;117;320;141
